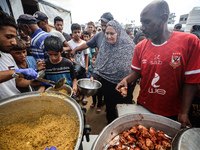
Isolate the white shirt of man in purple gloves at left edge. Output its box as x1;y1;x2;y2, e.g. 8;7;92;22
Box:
0;51;21;100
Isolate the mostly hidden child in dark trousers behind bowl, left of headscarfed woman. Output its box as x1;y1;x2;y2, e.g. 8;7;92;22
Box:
88;53;103;113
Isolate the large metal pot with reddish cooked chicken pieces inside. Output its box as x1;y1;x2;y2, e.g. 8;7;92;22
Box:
92;114;181;150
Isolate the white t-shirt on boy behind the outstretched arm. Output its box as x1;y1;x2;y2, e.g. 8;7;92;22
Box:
68;40;90;68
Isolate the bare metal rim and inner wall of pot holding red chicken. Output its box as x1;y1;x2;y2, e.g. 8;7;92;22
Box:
92;114;181;150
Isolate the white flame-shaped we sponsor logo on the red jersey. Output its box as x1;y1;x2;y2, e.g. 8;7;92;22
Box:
148;73;166;95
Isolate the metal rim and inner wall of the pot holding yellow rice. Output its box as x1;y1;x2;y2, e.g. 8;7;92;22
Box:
0;91;84;150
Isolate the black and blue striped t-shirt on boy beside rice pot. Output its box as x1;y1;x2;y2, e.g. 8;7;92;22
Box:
45;58;76;87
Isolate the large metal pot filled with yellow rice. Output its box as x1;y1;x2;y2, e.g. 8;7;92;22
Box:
0;91;84;150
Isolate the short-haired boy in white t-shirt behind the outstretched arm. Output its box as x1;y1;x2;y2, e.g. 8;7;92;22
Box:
68;23;90;79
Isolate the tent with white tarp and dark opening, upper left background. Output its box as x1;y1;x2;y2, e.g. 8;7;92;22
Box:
0;0;72;34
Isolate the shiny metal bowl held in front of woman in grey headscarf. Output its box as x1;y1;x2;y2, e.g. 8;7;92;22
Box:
77;78;102;96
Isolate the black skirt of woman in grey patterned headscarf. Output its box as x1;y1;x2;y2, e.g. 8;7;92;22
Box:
101;78;135;124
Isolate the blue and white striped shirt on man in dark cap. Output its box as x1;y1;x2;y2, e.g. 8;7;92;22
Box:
30;29;51;61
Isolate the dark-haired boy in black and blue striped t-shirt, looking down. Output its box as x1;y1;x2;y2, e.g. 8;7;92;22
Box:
44;36;77;95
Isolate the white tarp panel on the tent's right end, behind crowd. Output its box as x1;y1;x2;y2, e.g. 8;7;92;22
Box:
38;2;71;34
